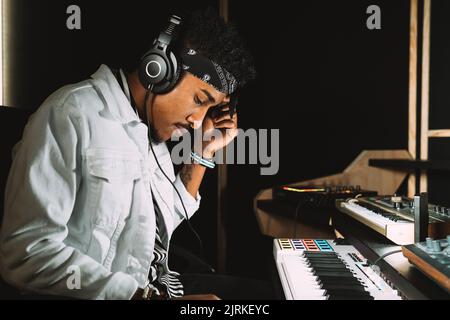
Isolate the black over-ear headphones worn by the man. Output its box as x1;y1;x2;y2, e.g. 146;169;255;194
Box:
139;15;181;94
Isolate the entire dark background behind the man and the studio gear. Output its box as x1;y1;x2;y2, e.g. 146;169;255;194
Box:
0;0;450;277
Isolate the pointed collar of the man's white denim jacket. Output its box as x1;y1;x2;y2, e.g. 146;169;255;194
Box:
91;64;141;124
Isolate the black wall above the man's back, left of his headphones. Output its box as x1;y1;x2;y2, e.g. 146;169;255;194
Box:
9;0;218;109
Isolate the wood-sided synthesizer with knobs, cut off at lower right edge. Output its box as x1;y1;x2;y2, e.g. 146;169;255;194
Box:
402;236;450;293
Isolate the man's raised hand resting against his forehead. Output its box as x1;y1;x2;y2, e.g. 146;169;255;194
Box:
197;106;238;159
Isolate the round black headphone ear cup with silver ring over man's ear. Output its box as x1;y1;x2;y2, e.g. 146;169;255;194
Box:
138;50;172;91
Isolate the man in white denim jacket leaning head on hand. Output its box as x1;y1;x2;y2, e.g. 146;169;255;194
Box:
0;9;268;299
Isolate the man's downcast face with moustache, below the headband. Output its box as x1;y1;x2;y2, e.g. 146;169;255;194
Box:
147;72;229;142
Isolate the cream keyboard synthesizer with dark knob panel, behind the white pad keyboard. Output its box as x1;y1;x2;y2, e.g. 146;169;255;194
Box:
336;196;450;245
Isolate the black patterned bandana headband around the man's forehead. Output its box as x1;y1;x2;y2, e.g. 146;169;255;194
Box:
180;49;238;95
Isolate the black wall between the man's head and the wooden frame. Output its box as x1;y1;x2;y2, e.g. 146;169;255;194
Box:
228;0;409;275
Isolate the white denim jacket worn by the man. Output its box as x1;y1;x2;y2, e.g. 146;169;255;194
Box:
0;65;200;299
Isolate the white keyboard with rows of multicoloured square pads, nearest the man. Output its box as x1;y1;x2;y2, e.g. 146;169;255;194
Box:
273;239;401;300
